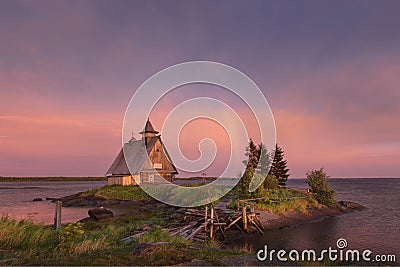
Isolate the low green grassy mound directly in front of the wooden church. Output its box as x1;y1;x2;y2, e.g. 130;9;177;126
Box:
81;185;152;200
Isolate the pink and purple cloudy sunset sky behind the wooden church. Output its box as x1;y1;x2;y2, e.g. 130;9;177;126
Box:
0;0;400;178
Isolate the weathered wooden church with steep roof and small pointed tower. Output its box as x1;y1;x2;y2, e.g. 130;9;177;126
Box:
106;120;178;186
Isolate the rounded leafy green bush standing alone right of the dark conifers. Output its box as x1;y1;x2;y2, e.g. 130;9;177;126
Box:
306;168;336;207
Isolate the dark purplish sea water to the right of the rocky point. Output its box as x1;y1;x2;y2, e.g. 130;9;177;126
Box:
233;179;400;264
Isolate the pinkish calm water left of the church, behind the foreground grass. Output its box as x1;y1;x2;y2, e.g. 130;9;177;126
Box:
0;181;106;225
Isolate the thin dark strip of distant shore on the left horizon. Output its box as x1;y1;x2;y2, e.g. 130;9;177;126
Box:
0;176;107;183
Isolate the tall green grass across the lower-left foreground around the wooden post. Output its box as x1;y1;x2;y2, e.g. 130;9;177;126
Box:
0;217;246;265
